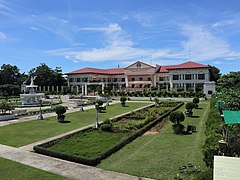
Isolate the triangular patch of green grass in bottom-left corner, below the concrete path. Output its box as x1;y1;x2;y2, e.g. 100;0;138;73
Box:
0;158;67;180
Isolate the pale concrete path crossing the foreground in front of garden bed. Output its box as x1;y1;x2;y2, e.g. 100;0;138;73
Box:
0;144;151;180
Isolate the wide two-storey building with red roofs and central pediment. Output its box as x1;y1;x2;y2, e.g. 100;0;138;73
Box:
67;61;215;95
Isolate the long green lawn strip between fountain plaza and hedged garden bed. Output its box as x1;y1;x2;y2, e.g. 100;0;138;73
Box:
0;102;148;147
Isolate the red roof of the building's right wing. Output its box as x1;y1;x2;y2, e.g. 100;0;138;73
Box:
158;61;210;73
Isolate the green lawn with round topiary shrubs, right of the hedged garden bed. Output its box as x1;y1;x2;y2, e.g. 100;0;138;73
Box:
98;103;209;179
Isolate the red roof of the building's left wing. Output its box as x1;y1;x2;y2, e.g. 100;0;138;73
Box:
66;67;124;75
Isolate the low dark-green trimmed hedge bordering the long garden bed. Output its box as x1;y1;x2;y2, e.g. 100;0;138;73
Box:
33;102;184;166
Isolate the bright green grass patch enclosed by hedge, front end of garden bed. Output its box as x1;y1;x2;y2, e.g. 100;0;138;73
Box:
49;130;130;157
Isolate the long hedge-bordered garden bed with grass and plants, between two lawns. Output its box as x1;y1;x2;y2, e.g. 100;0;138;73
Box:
34;100;183;165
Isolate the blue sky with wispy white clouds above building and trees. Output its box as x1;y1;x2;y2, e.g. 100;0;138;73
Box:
0;0;240;74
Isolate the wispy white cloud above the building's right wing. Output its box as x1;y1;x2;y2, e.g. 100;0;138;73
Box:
182;25;240;61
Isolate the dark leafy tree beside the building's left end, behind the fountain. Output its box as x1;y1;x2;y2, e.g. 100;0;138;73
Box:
29;63;66;86
